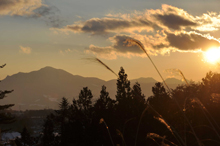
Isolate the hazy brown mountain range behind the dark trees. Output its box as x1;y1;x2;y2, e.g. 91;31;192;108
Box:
0;67;184;110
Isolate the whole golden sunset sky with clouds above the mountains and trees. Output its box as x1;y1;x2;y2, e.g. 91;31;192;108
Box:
0;0;220;81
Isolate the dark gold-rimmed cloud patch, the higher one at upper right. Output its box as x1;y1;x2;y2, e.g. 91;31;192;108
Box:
154;14;198;30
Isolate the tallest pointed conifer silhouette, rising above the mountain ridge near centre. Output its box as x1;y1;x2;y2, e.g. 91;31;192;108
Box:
114;67;137;145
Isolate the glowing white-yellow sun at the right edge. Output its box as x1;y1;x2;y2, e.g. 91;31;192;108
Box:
204;47;220;64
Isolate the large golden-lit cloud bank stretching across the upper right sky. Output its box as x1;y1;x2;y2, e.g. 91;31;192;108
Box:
56;4;220;59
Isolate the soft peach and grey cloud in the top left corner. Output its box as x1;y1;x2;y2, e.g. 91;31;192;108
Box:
0;0;64;28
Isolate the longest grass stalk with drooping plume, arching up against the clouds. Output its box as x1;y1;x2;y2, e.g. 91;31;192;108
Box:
127;39;201;146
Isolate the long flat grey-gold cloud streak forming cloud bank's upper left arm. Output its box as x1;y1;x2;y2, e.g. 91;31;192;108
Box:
57;18;157;34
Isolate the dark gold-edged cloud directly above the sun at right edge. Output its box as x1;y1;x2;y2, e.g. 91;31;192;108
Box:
166;33;220;51
